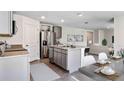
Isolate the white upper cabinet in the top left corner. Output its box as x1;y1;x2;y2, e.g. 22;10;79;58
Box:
0;11;12;35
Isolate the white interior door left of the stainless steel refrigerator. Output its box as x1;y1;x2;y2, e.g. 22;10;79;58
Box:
24;23;39;61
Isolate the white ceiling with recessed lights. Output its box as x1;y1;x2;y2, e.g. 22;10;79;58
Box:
14;11;124;29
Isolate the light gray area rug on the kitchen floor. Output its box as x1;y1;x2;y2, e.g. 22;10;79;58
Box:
30;63;60;81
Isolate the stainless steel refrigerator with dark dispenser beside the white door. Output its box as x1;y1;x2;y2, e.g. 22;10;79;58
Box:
40;25;56;59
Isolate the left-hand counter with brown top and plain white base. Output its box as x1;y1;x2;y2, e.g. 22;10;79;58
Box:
0;49;30;81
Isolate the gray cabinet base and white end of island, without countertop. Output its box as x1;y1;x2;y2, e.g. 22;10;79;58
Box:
54;48;81;73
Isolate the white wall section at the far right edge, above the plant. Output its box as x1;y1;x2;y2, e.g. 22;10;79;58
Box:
114;16;124;54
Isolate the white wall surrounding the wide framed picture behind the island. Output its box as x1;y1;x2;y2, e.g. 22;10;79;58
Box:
59;26;87;46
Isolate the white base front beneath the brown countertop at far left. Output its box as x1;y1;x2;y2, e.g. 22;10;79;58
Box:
0;56;30;81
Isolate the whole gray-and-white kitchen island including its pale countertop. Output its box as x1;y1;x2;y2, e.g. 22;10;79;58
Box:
49;45;85;73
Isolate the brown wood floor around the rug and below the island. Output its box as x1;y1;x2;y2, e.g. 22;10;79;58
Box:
31;59;92;81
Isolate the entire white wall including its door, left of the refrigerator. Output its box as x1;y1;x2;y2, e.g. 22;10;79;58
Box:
0;15;40;61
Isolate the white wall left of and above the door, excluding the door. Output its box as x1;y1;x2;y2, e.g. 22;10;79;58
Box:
0;14;39;44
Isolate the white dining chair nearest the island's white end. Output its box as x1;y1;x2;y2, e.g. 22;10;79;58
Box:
81;55;96;67
